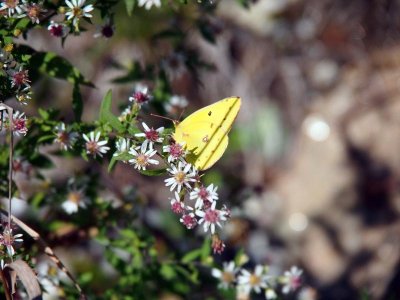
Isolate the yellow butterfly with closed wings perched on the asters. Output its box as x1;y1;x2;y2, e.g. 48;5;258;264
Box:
173;97;241;170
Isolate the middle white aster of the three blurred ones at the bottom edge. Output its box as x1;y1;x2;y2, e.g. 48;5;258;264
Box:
238;265;269;294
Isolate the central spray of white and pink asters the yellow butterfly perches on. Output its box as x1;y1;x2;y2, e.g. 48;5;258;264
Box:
109;85;230;253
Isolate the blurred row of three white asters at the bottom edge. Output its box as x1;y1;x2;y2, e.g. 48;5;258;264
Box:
211;261;303;300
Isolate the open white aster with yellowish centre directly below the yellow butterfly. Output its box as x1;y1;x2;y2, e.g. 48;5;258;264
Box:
164;161;197;193
